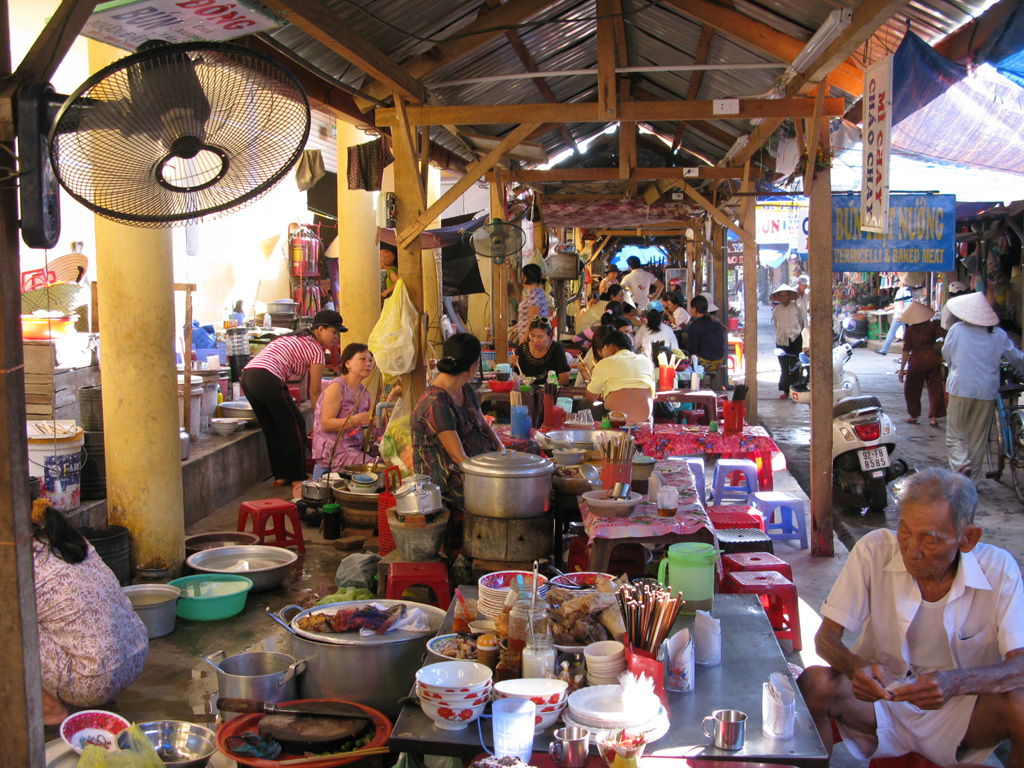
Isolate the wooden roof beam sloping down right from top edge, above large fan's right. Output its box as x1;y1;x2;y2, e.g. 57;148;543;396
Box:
264;0;427;102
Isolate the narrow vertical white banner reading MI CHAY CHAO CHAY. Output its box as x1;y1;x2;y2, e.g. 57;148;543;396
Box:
860;55;893;234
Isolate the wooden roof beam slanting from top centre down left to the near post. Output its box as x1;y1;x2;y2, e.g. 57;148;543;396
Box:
362;0;565;110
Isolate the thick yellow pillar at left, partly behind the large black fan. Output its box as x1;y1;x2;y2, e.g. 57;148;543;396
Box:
89;40;184;569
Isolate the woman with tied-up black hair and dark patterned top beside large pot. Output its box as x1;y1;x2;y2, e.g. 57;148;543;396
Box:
412;334;502;510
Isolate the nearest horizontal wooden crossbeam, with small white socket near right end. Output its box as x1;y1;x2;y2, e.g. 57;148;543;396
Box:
376;96;839;126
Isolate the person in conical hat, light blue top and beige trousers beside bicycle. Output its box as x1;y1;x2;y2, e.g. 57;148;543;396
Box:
942;293;1024;484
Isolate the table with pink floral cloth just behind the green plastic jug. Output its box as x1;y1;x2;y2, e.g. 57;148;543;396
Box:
580;459;715;571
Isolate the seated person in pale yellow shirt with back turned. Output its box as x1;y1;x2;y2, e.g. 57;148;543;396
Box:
587;331;655;424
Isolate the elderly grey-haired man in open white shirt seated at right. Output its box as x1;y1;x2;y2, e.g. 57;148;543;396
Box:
799;468;1024;768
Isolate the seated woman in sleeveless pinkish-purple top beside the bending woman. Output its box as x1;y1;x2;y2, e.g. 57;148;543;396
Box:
313;344;374;480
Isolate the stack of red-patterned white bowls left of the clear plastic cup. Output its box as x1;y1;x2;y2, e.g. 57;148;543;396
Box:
416;662;490;731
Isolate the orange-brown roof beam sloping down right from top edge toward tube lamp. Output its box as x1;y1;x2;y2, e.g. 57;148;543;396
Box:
665;0;869;96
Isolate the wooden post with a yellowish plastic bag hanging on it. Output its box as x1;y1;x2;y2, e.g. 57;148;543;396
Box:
392;94;426;407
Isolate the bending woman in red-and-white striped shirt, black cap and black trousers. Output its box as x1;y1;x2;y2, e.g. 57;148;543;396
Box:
242;309;348;496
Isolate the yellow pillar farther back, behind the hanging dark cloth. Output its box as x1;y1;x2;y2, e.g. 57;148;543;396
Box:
337;120;384;346
